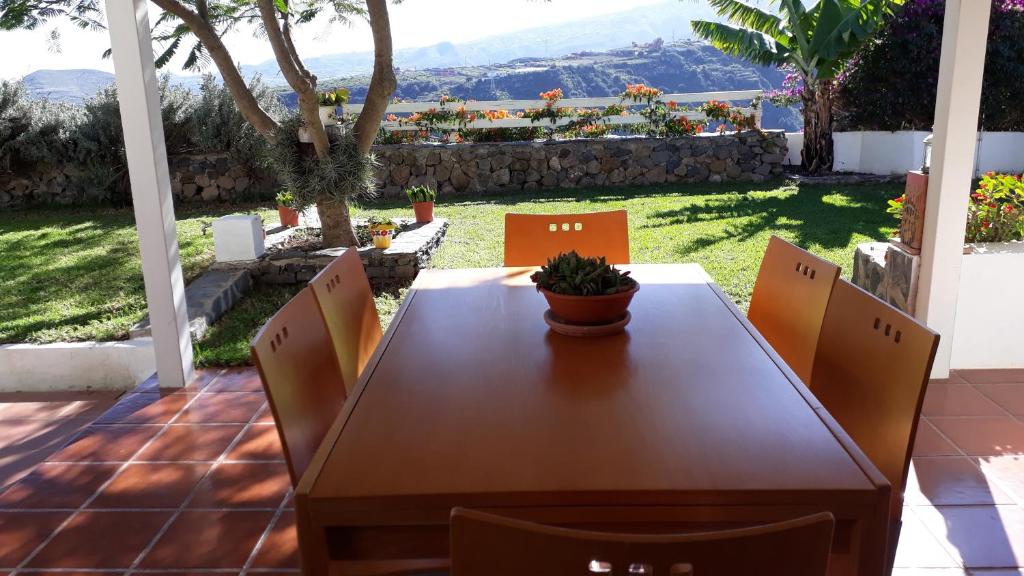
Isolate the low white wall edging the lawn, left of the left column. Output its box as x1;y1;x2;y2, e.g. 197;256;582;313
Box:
0;338;157;392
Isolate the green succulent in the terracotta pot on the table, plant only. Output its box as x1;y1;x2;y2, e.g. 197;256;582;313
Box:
529;251;636;296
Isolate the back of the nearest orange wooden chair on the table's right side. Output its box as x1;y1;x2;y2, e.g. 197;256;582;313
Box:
809;280;939;510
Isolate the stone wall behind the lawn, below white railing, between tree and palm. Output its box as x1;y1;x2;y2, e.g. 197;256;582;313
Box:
376;131;786;197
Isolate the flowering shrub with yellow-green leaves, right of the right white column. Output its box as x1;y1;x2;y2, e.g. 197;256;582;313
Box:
967;172;1024;242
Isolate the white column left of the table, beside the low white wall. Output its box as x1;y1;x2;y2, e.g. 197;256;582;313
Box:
106;0;193;387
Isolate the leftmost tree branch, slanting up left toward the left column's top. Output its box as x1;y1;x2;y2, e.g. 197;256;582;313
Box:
153;0;278;138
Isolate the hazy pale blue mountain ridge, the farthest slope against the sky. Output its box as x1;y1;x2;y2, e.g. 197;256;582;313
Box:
243;0;716;84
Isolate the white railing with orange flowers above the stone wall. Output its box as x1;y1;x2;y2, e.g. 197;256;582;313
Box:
345;90;762;131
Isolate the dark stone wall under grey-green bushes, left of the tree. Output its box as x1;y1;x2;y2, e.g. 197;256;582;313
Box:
0;154;280;209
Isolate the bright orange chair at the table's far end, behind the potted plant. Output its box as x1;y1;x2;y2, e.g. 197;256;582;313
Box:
505;210;630;266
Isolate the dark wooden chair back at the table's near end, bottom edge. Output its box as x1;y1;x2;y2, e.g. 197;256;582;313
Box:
452;508;835;576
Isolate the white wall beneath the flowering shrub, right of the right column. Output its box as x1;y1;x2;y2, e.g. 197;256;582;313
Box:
950;242;1024;369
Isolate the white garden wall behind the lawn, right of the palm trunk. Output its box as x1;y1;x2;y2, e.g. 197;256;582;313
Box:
833;130;1024;175
